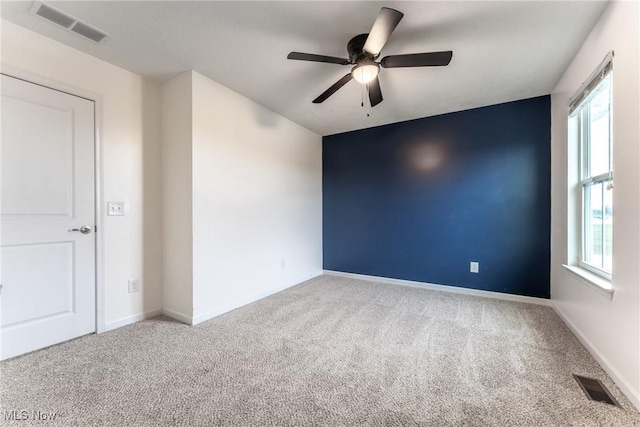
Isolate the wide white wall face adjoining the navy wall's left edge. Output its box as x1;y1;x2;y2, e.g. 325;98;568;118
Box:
192;73;322;323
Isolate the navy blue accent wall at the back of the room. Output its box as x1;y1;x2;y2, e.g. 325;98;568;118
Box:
322;96;551;298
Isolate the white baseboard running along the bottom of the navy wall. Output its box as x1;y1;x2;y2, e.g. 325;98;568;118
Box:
324;270;551;307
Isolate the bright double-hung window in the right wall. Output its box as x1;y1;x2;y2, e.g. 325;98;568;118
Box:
569;54;613;280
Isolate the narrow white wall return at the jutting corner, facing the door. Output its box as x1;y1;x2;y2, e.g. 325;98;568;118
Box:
162;73;193;323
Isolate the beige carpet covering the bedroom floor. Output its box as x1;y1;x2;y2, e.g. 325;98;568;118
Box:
0;276;640;426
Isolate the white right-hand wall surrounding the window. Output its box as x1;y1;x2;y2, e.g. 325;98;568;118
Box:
551;1;640;409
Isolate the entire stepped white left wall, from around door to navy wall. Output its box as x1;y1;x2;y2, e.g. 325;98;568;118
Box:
1;21;322;328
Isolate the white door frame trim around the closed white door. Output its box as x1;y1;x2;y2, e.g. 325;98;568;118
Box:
0;64;106;334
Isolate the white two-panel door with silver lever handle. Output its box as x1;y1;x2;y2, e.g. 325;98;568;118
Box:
0;75;96;359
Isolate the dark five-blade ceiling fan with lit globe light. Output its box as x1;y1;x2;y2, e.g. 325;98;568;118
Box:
287;7;453;107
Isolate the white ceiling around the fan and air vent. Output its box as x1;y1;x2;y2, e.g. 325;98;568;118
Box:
1;1;606;135
